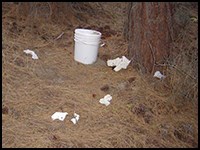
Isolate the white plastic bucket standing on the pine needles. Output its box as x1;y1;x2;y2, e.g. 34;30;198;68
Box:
74;29;101;64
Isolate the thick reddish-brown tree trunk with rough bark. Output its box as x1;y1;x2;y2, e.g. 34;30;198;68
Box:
128;2;172;73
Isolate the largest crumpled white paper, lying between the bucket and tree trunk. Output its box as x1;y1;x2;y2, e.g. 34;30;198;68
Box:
107;56;131;72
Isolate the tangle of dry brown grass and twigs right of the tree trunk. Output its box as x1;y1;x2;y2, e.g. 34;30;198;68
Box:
149;3;198;103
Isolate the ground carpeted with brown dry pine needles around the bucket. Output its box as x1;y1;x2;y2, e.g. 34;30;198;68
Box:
2;3;198;148
